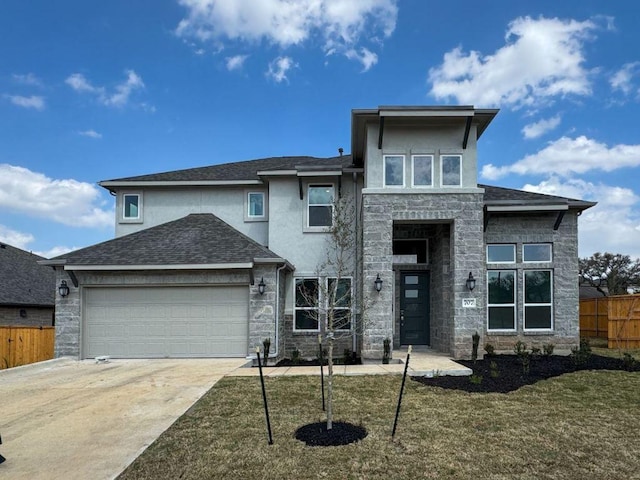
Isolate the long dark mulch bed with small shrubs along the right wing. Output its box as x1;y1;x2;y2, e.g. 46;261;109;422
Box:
413;355;640;393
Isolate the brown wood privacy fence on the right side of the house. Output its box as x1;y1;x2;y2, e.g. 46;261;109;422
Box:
580;295;640;348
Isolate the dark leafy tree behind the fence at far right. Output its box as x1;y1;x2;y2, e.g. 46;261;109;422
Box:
579;252;640;295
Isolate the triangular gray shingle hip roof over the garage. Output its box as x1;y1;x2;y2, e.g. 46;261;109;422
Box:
53;213;280;266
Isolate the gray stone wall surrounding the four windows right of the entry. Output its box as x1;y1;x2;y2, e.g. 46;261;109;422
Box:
480;211;580;352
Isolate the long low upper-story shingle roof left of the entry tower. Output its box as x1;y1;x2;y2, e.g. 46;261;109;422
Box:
101;155;352;183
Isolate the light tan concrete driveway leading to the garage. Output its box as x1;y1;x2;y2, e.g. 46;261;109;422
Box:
0;359;246;480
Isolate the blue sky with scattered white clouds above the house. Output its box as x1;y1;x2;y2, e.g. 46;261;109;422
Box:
0;0;640;258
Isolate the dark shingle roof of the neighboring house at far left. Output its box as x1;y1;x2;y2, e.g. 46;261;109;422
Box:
0;243;56;307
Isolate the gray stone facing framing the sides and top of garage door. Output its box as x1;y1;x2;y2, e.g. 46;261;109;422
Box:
55;265;275;358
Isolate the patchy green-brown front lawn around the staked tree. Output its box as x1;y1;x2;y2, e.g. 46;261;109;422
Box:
119;371;640;480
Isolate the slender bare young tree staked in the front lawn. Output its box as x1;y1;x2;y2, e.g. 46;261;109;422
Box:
296;197;362;430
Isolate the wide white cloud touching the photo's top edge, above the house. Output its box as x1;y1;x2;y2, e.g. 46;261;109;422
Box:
176;0;398;70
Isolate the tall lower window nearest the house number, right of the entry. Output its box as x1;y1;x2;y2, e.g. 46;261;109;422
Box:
487;270;516;330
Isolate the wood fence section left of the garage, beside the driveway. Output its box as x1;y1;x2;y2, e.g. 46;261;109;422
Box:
0;327;56;370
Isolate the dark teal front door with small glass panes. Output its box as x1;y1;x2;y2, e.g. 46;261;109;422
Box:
400;272;431;345
